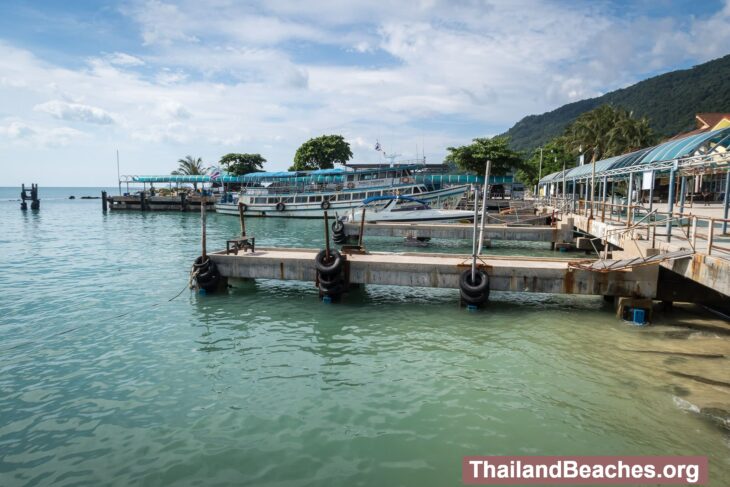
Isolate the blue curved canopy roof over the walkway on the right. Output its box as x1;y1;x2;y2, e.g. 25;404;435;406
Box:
539;127;730;185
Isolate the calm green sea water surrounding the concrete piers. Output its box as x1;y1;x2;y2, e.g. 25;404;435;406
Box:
0;188;730;486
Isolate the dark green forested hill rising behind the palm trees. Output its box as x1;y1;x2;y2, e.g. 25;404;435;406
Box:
504;55;730;151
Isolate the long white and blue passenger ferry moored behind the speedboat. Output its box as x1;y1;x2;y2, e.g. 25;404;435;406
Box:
216;165;466;218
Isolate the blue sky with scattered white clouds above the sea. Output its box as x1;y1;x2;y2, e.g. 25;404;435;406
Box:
0;0;730;186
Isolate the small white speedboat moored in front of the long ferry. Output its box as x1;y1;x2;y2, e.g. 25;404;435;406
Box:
342;195;474;223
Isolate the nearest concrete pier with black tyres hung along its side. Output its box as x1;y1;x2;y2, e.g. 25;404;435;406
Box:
208;248;658;298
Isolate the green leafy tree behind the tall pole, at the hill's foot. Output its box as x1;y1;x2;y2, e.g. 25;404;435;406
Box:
444;137;522;176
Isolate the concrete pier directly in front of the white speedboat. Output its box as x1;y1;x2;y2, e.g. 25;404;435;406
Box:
345;222;573;244
